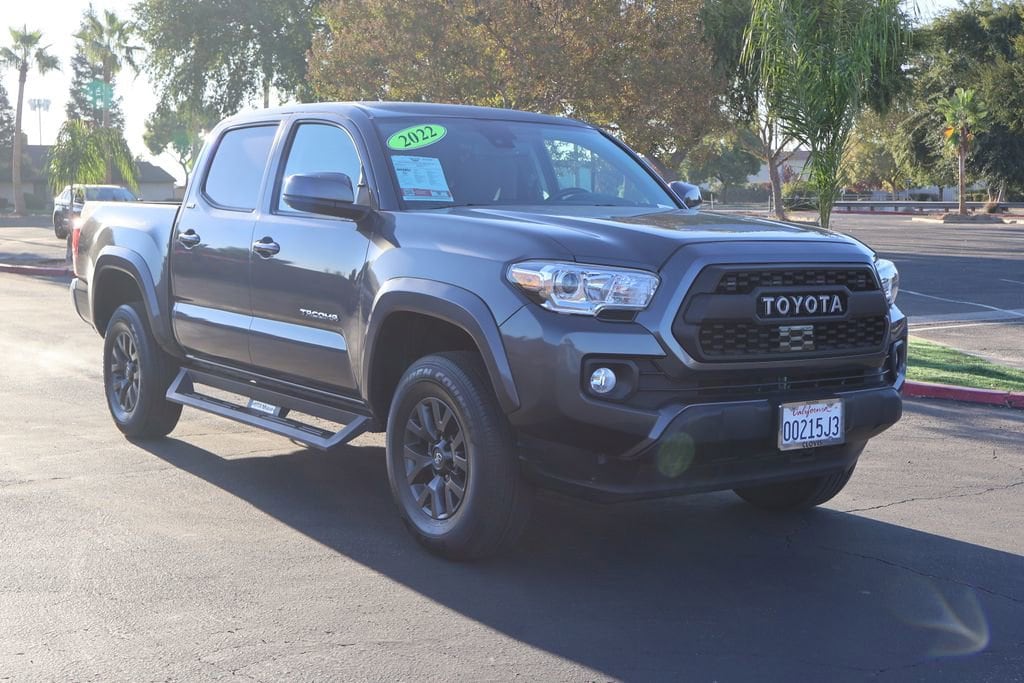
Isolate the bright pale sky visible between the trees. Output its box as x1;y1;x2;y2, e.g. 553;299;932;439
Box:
0;0;959;187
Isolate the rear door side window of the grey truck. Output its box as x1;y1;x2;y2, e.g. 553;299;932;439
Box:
203;125;278;211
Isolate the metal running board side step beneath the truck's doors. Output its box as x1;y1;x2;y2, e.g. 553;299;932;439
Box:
167;368;370;451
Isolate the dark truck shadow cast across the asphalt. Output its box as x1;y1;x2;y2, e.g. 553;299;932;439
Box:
143;428;1024;681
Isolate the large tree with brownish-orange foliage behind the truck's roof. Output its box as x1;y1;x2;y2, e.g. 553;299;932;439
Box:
309;0;720;174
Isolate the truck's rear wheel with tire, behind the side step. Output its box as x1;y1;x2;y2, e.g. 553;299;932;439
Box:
103;302;181;438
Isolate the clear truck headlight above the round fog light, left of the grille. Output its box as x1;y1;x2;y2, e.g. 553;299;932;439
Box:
508;261;659;315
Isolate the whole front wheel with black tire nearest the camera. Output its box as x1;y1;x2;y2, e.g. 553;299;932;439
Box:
387;351;532;560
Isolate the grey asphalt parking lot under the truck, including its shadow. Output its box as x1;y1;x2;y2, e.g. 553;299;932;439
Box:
0;273;1024;681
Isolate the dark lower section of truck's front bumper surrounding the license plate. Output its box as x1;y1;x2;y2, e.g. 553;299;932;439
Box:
521;387;902;502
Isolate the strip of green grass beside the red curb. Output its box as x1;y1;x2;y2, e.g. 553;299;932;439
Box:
906;337;1024;391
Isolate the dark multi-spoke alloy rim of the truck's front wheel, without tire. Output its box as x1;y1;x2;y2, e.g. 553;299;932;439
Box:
402;396;469;520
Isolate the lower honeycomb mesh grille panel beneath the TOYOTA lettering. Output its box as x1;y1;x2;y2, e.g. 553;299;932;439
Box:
699;316;886;357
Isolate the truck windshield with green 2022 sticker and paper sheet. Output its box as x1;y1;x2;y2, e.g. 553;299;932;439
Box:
377;117;677;209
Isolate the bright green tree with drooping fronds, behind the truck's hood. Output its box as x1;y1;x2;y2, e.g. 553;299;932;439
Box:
744;0;908;227
